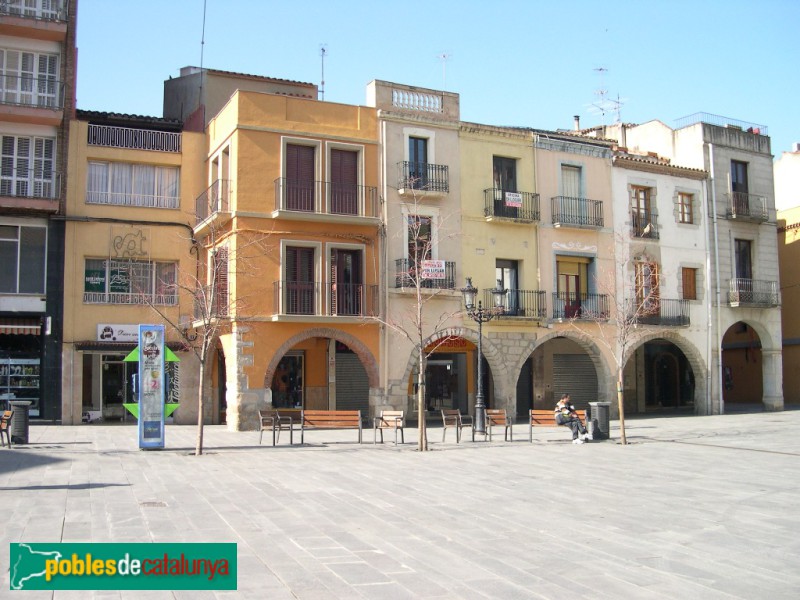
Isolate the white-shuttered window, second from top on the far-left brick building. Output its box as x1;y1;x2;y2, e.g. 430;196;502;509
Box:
0;49;60;107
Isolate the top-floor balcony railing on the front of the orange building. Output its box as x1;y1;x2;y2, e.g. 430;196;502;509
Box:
275;177;379;218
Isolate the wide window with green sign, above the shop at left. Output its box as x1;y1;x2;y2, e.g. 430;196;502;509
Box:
83;258;178;306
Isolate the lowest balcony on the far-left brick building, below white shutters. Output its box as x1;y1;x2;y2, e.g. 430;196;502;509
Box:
0;169;61;212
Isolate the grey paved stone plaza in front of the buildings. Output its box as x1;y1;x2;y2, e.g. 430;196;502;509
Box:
0;411;800;600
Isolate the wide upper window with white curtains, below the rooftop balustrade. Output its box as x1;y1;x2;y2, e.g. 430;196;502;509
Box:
86;162;180;208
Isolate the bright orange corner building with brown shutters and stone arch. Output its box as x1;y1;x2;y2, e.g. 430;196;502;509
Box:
200;91;380;430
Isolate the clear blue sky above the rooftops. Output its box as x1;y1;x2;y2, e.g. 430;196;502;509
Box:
77;0;800;157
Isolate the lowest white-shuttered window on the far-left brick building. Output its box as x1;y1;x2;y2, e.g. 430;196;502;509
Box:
0;134;56;198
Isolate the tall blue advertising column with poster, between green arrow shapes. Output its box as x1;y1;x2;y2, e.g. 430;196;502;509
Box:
139;325;166;449
